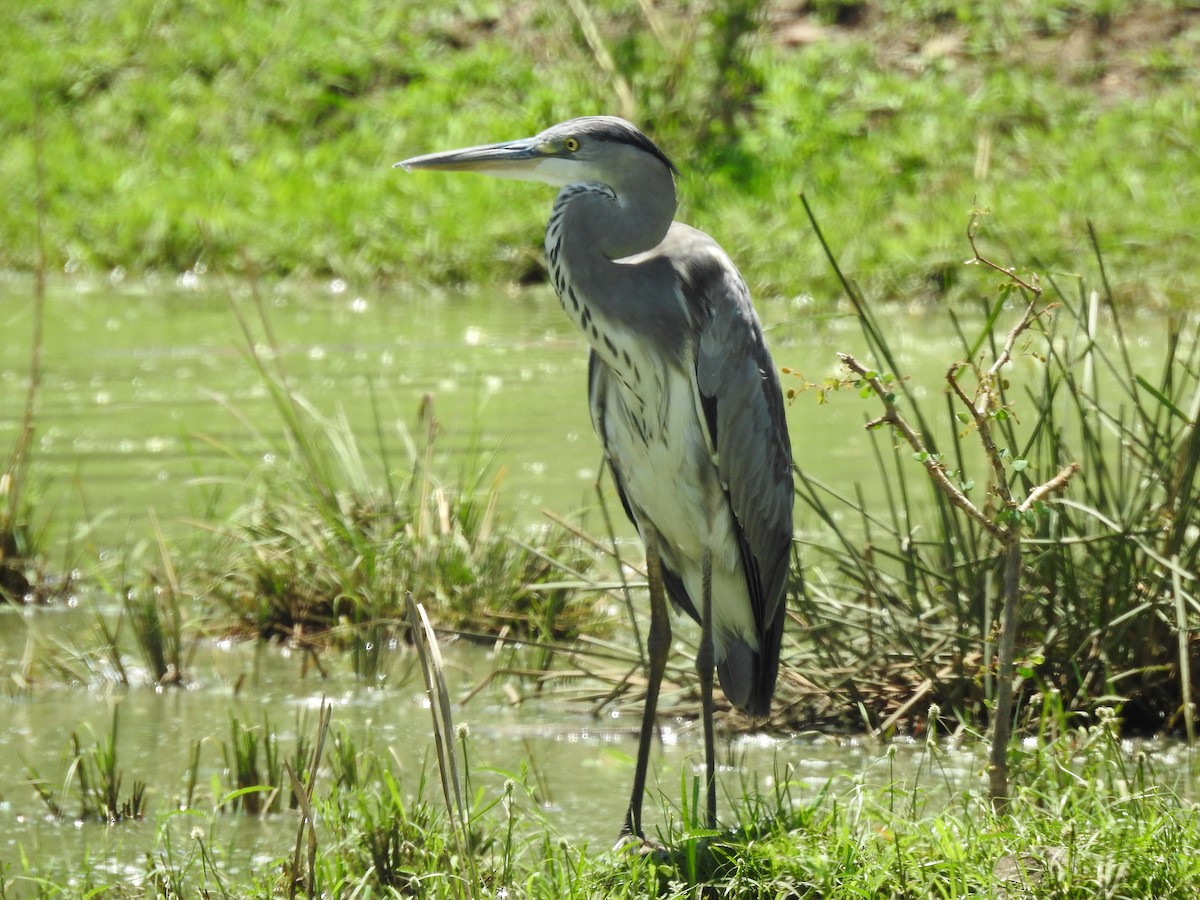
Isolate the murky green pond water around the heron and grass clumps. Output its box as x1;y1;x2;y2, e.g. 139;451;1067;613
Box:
0;274;1195;888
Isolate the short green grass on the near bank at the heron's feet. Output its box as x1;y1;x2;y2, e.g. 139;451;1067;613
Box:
9;704;1200;900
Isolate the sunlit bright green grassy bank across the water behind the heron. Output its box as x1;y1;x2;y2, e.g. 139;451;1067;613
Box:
0;0;1200;305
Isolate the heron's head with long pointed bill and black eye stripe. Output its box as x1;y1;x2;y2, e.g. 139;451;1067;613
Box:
396;115;677;187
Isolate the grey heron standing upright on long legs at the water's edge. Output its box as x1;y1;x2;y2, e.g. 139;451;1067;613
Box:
396;116;792;840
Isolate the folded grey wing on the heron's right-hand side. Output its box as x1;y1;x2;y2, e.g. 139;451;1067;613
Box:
685;253;793;662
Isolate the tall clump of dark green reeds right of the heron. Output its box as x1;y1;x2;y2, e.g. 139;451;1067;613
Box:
798;204;1200;763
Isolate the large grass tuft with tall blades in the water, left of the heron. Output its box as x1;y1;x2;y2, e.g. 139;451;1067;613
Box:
204;292;602;676
